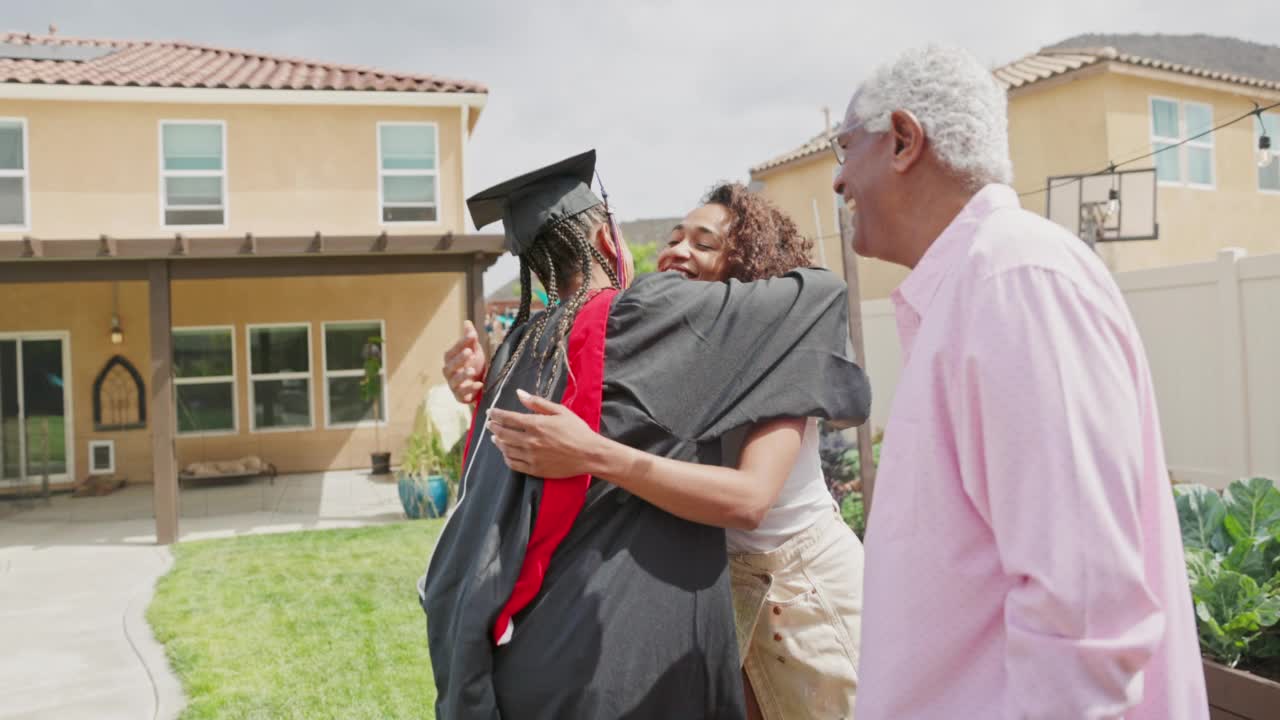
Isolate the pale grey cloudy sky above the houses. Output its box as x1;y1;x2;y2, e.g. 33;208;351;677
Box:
0;0;1280;288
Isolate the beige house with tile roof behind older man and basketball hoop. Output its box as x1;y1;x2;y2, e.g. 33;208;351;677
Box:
751;35;1280;299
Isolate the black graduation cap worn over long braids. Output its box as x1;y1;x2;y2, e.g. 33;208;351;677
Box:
467;150;602;255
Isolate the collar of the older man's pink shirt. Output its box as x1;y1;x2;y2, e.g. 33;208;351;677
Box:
892;183;1020;315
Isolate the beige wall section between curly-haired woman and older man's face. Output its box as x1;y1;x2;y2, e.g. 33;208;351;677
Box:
753;152;906;300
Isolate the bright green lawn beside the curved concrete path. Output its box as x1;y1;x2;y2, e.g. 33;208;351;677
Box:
147;520;443;720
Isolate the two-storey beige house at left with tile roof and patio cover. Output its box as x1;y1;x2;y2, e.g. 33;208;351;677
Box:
0;33;502;542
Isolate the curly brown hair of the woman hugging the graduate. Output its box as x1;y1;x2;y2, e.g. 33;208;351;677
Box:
703;183;813;282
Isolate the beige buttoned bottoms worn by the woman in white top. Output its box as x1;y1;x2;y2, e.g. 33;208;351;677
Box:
730;510;863;720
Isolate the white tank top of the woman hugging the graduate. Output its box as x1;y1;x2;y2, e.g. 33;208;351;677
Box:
723;418;835;552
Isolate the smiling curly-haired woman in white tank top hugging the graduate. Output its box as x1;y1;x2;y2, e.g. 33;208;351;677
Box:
490;184;863;719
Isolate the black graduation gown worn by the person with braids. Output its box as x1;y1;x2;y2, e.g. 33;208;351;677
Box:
420;269;870;720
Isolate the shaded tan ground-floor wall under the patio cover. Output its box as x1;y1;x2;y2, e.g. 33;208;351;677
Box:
0;273;466;482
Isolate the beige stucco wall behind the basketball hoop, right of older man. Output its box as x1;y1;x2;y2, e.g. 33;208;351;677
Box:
1009;72;1280;272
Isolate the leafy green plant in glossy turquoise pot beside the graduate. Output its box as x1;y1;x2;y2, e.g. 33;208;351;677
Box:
397;409;462;518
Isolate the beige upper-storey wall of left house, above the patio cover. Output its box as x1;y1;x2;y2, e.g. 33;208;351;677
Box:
0;100;465;240
